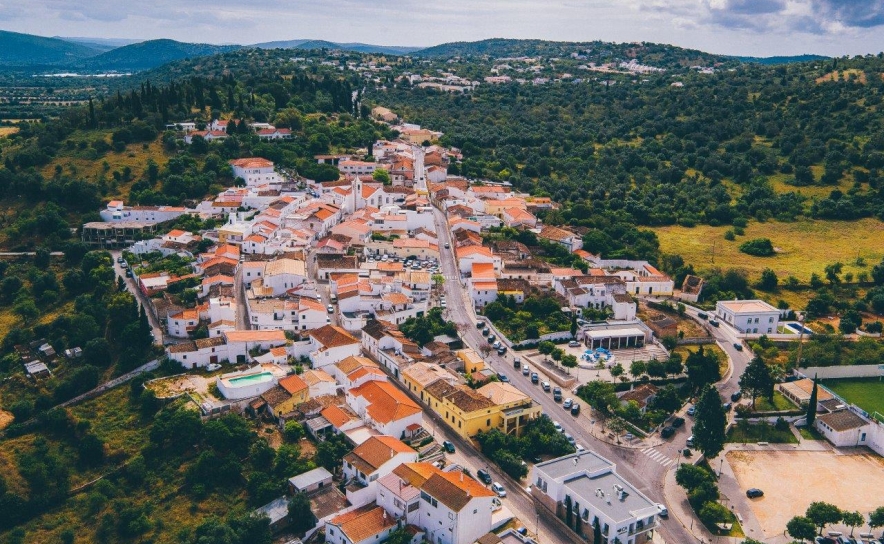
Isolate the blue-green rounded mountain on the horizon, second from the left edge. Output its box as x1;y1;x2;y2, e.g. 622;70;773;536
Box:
83;40;242;71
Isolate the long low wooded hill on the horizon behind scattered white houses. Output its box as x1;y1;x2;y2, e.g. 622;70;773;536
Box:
412;38;734;68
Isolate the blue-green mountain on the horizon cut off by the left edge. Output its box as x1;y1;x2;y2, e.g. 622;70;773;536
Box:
0;30;101;67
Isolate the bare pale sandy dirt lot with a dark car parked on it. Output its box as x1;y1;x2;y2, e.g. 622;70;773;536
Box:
727;451;884;537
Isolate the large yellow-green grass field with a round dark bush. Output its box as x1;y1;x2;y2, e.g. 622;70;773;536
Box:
654;219;884;282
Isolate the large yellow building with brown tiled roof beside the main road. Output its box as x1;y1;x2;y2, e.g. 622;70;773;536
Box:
424;380;541;438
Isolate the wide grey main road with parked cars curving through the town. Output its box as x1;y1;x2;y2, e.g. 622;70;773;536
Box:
433;208;696;544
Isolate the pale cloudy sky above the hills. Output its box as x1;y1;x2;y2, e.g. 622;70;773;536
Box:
0;0;884;56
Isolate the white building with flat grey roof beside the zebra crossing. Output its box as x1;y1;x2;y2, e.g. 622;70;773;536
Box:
529;451;658;544
